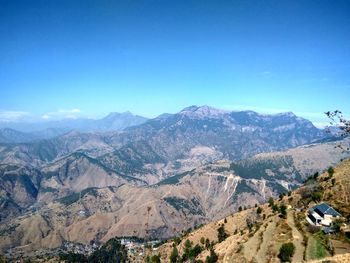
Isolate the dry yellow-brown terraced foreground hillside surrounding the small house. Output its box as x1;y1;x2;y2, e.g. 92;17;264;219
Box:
153;159;350;262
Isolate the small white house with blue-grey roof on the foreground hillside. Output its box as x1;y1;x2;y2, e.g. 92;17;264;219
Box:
306;203;341;226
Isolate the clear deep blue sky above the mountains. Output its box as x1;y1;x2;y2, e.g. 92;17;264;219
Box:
0;0;350;127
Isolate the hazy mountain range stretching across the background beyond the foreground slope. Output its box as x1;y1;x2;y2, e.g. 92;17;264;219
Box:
0;106;349;258
